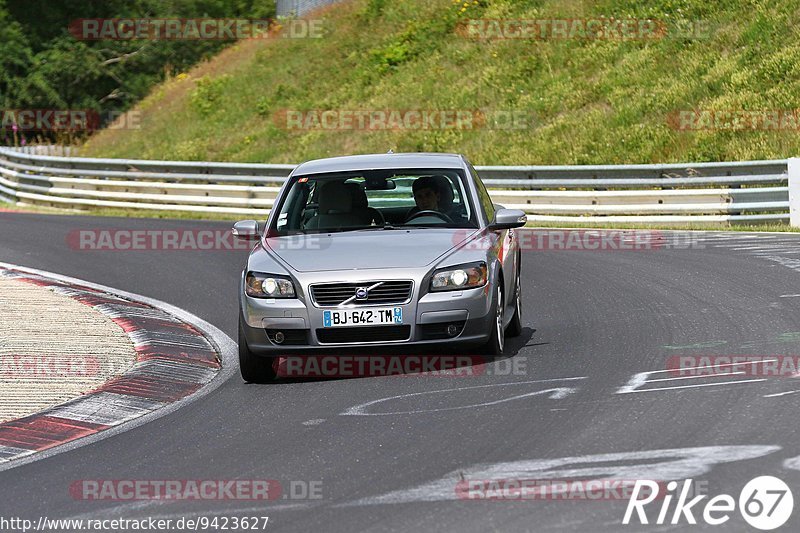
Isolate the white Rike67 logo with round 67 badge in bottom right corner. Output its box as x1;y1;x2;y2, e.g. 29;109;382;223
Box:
622;476;794;531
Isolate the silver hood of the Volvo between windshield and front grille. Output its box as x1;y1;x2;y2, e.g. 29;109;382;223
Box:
265;228;478;272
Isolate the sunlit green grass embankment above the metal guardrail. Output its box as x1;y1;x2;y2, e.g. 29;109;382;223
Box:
82;0;800;164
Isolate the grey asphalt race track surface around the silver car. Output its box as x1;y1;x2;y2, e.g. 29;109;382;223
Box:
0;213;800;532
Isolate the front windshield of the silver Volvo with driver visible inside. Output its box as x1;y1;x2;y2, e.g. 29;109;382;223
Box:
273;169;478;235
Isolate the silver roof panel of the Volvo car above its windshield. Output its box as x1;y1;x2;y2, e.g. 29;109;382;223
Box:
292;153;465;175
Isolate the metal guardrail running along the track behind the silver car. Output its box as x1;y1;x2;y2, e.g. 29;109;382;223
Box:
0;148;789;223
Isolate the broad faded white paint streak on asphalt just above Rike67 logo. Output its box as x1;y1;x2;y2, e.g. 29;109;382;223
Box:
337;445;781;507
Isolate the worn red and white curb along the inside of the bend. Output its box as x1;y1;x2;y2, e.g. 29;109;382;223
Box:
0;263;236;470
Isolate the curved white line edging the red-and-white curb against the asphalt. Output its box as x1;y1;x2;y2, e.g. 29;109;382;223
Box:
0;262;238;472
